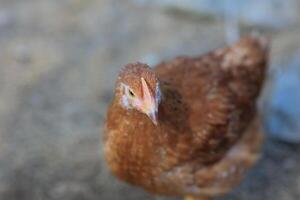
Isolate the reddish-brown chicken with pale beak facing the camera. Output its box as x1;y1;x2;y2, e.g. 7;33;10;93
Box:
104;37;268;199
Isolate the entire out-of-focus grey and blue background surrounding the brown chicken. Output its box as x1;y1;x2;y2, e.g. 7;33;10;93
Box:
0;0;300;200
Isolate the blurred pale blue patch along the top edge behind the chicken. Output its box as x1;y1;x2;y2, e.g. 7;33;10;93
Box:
133;0;299;28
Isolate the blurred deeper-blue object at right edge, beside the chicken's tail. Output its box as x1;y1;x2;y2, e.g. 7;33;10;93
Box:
263;51;300;143
